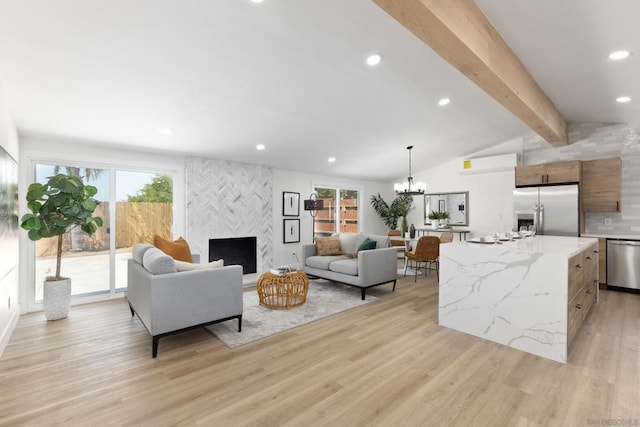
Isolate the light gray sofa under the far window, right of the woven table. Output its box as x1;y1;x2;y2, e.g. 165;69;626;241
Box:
302;233;398;300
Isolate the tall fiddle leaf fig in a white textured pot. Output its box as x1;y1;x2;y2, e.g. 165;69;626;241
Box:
20;174;103;320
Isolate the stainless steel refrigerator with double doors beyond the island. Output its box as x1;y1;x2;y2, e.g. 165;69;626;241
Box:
513;184;580;236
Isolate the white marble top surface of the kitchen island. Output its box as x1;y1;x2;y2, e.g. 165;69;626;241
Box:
453;236;597;257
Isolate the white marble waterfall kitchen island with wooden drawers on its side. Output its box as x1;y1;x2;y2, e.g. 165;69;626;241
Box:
438;236;598;363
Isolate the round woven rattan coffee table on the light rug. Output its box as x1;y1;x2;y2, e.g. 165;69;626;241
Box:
256;271;309;308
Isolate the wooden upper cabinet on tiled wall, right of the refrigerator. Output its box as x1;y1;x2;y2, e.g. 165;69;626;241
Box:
582;157;622;212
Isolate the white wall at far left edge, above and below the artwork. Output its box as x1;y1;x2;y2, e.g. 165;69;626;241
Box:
0;83;20;355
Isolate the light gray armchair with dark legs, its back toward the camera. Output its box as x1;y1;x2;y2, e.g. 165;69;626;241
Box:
127;245;243;358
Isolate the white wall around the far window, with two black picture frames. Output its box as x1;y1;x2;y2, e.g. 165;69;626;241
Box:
272;169;395;266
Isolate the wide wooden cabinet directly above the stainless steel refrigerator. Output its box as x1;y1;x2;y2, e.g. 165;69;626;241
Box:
516;160;582;187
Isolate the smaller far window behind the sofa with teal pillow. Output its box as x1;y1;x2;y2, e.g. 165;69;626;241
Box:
313;186;360;237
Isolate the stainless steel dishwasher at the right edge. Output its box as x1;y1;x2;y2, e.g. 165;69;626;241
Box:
607;240;640;289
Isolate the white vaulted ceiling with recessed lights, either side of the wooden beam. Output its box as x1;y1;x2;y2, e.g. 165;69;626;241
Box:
0;0;640;180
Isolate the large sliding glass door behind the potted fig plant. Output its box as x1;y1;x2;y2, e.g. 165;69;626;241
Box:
30;163;173;306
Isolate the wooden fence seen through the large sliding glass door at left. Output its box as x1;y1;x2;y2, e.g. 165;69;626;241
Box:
36;202;173;257
